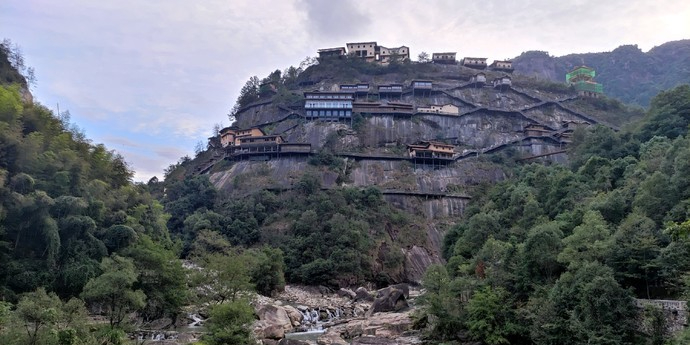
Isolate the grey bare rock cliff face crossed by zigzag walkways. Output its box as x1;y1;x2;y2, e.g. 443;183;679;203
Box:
199;61;637;282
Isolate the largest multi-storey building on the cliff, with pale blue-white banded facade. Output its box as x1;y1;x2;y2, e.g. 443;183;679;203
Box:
304;91;354;121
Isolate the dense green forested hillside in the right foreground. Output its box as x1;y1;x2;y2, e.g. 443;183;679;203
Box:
420;85;690;344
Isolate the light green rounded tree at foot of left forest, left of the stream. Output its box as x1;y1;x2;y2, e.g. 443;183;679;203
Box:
82;255;146;328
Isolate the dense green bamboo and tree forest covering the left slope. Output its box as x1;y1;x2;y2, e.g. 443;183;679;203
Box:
0;41;283;345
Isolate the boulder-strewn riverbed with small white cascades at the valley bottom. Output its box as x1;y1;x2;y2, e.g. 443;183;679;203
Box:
130;284;421;345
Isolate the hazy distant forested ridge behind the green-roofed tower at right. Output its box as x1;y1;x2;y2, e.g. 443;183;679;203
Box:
513;40;690;106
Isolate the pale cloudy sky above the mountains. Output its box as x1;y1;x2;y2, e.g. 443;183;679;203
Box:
0;0;690;181
